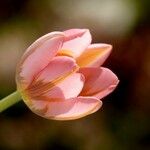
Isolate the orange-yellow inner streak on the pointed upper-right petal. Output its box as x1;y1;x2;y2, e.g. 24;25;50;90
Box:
76;48;107;67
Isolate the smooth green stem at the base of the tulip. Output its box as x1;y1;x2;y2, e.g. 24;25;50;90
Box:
0;91;21;112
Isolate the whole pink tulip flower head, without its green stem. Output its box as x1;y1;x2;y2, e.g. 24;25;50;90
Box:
16;29;119;120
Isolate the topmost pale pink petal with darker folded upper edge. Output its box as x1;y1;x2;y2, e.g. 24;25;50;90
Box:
59;29;91;58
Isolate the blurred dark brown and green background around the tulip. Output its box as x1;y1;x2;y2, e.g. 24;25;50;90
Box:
0;0;150;150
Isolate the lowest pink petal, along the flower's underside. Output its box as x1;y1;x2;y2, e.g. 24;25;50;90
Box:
32;97;102;120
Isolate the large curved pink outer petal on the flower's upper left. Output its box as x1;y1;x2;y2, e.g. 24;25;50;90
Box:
16;32;64;88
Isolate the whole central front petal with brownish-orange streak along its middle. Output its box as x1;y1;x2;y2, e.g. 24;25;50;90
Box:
27;56;80;99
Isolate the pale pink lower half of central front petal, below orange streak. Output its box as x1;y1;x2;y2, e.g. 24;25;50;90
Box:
45;73;84;99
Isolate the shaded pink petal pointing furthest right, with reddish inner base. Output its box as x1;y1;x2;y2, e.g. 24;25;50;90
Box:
80;67;119;99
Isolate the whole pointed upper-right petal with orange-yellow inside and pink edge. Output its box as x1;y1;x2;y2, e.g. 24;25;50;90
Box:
76;44;112;67
